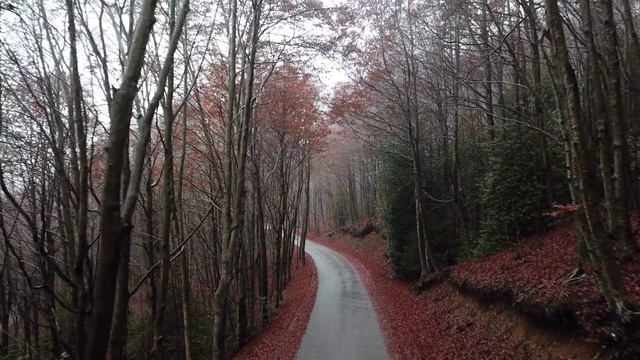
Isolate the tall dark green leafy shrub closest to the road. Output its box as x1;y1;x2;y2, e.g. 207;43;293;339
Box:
378;144;420;278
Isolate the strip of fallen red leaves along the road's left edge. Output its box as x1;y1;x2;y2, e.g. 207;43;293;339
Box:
234;256;318;360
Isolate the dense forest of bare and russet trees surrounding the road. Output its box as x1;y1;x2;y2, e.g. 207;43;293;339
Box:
0;0;640;360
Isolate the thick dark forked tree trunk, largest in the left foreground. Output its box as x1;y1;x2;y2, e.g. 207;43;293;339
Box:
84;0;189;360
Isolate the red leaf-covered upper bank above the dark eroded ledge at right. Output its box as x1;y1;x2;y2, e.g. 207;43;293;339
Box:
452;221;640;341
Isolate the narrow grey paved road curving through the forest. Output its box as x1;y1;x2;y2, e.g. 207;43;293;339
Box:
296;241;389;360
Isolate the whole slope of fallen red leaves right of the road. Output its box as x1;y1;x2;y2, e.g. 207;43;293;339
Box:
312;219;640;359
